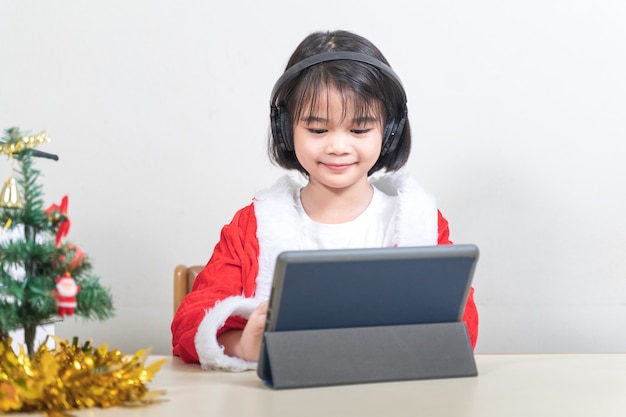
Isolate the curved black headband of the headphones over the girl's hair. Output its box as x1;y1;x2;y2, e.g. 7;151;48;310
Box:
270;51;406;106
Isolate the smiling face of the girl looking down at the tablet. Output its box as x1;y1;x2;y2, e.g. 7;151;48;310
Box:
293;87;382;190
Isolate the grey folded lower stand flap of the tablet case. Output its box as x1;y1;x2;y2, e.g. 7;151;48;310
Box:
265;322;478;389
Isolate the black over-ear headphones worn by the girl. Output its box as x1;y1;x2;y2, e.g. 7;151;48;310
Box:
270;52;407;155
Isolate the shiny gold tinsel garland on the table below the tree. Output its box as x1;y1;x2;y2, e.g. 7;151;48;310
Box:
0;339;167;415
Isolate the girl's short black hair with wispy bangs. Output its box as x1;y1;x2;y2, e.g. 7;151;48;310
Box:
268;30;411;175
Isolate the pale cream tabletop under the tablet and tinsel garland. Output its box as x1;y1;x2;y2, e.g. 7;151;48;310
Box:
11;354;626;417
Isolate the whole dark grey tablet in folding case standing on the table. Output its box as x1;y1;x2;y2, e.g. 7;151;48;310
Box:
257;245;478;389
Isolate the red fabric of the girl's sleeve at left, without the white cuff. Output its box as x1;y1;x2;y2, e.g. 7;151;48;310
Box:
171;204;259;363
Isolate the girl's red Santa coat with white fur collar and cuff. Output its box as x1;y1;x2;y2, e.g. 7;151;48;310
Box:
171;173;478;371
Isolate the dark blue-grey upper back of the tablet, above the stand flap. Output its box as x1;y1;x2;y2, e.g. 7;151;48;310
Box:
257;244;479;381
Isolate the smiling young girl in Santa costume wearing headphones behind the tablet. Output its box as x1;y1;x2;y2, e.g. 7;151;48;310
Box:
172;31;478;371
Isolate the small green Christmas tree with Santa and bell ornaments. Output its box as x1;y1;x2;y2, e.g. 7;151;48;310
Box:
0;128;113;356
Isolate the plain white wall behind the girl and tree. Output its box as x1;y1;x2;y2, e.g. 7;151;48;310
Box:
0;0;626;353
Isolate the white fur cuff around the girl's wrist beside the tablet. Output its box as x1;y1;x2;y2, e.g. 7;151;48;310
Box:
194;296;261;372
